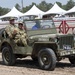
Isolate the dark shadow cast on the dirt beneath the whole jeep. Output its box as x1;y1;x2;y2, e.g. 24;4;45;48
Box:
0;59;75;69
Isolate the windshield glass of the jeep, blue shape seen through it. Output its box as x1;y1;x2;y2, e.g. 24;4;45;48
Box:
25;19;54;30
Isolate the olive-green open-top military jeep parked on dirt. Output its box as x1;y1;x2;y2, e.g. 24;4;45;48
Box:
0;18;75;71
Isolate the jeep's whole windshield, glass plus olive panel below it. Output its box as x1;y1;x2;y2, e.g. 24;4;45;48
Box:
24;19;57;36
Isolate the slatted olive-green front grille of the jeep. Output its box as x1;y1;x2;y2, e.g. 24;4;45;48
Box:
59;35;74;49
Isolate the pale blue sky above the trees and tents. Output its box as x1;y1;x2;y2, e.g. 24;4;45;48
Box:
0;0;75;8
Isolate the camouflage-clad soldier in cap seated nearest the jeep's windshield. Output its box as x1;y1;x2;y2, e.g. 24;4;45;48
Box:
15;22;27;46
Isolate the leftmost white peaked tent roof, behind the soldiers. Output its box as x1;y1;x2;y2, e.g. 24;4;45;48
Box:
0;7;23;18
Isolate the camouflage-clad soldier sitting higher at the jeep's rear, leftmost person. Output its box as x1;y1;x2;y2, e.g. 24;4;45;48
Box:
5;18;17;38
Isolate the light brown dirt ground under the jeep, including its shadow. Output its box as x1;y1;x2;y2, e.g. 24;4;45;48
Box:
0;54;75;75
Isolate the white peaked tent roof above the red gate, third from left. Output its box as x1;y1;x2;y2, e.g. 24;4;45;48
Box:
45;3;66;14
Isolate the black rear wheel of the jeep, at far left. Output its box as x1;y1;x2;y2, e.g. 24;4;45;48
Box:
2;46;16;66
